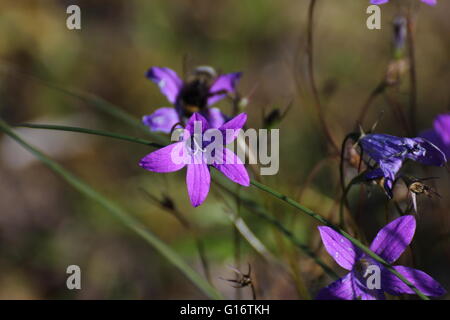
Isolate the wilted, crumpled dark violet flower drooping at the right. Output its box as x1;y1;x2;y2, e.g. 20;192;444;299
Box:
359;134;447;198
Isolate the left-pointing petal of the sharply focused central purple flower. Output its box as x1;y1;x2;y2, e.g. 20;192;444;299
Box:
139;142;186;172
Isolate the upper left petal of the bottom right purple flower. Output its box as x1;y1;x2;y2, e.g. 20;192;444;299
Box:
318;226;360;270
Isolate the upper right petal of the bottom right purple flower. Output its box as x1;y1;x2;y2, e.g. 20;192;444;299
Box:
370;215;416;263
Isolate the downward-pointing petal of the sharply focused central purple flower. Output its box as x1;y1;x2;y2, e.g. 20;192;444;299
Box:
186;153;211;207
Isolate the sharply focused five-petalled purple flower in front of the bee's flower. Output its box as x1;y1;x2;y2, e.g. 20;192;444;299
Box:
139;112;250;207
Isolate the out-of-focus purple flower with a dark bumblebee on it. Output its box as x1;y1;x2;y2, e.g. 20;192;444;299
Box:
142;67;241;133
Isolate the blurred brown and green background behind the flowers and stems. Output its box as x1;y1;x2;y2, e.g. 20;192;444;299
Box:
0;0;450;299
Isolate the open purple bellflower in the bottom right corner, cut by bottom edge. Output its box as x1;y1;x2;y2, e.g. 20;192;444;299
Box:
317;215;446;300
